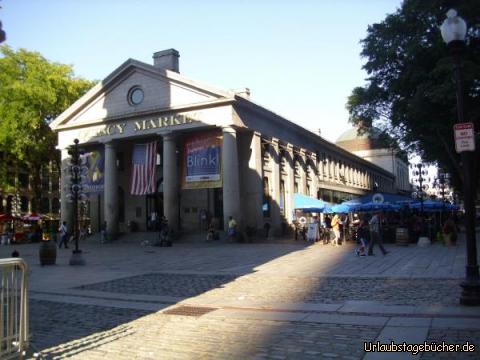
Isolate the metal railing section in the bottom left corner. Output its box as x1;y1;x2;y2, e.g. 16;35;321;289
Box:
0;258;29;360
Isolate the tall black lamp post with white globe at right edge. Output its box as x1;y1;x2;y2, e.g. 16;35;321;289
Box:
440;9;480;306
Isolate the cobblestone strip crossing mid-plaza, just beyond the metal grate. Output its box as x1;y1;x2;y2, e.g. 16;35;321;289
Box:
81;273;461;305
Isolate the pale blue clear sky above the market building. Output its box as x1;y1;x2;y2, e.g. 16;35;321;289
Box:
0;0;401;141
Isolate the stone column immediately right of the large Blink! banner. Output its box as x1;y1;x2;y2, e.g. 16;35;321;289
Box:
222;126;242;229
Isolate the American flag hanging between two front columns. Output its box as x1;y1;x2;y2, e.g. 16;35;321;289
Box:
130;141;157;195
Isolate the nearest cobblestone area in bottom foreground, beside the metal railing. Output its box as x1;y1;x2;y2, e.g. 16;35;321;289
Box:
31;301;381;360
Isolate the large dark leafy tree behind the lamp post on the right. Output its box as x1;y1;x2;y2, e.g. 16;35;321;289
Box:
347;0;480;195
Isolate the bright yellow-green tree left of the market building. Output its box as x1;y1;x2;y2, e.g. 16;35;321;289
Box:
0;45;94;208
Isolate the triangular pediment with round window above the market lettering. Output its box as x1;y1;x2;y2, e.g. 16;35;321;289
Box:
51;59;233;130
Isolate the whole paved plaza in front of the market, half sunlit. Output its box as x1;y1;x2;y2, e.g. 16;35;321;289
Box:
0;234;480;359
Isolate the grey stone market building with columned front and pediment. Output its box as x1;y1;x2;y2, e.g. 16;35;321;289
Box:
51;49;395;237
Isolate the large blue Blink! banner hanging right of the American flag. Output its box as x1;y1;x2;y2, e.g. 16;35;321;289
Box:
183;131;222;189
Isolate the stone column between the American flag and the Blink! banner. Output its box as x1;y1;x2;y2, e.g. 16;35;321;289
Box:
163;133;179;231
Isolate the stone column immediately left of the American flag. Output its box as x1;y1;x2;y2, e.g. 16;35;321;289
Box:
103;141;118;240
